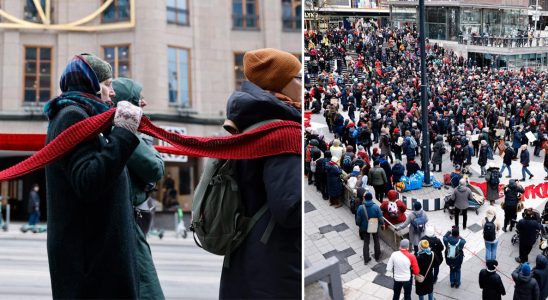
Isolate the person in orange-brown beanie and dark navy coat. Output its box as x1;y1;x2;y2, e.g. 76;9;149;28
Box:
219;49;303;299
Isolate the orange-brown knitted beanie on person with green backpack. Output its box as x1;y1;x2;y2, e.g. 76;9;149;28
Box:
244;48;302;92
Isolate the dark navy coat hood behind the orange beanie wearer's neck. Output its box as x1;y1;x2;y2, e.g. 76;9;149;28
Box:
226;81;301;132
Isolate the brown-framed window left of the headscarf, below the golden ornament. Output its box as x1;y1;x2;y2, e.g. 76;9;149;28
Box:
23;47;52;103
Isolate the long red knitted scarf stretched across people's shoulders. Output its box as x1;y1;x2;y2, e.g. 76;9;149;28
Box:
0;108;302;181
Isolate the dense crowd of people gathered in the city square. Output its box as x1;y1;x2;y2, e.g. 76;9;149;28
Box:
304;21;548;299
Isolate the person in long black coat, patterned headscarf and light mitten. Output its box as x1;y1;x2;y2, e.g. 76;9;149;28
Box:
44;55;142;299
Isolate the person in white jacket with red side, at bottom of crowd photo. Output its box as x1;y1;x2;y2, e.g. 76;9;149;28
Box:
386;239;420;300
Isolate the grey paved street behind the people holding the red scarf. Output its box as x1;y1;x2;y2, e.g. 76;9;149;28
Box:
0;224;223;300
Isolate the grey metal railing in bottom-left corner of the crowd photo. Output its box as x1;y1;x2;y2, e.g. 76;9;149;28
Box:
304;256;344;300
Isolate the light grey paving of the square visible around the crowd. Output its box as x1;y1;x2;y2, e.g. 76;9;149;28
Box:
303;110;546;299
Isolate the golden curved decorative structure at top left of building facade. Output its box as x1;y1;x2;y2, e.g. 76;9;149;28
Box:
0;0;135;32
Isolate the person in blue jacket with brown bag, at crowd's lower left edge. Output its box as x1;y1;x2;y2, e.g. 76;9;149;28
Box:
356;187;385;264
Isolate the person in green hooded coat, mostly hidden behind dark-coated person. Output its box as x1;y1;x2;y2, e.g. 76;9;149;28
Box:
112;78;165;299
